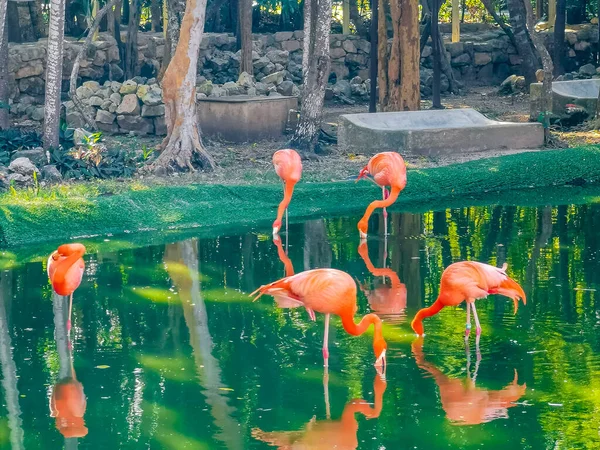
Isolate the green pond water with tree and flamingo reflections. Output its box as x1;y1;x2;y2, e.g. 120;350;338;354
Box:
0;201;600;450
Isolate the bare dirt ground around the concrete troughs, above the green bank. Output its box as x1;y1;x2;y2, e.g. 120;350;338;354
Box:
105;86;600;184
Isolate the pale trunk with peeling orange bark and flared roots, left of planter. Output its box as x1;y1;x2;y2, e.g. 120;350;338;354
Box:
151;0;215;172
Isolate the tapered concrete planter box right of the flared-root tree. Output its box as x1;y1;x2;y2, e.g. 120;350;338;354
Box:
197;95;298;142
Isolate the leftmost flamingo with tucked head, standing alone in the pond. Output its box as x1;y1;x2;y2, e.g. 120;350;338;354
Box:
48;244;85;333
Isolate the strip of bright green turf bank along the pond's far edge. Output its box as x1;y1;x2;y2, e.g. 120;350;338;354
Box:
0;147;600;255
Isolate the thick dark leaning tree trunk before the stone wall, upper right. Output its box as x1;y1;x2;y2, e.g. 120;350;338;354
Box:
507;0;541;85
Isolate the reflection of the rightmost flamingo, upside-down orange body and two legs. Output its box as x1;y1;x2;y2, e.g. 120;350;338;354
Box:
411;337;527;425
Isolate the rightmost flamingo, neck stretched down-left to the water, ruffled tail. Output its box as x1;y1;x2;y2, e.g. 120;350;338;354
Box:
411;261;527;337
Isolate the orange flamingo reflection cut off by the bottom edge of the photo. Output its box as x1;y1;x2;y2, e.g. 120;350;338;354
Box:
252;372;386;450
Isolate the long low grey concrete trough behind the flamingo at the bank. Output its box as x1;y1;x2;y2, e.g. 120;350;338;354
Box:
338;108;544;156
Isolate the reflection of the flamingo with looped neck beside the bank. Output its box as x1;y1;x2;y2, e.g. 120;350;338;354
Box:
358;241;406;316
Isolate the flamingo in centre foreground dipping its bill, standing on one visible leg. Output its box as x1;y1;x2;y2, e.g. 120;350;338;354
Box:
250;269;387;368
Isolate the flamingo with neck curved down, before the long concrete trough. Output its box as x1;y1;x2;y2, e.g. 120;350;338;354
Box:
356;152;406;238
